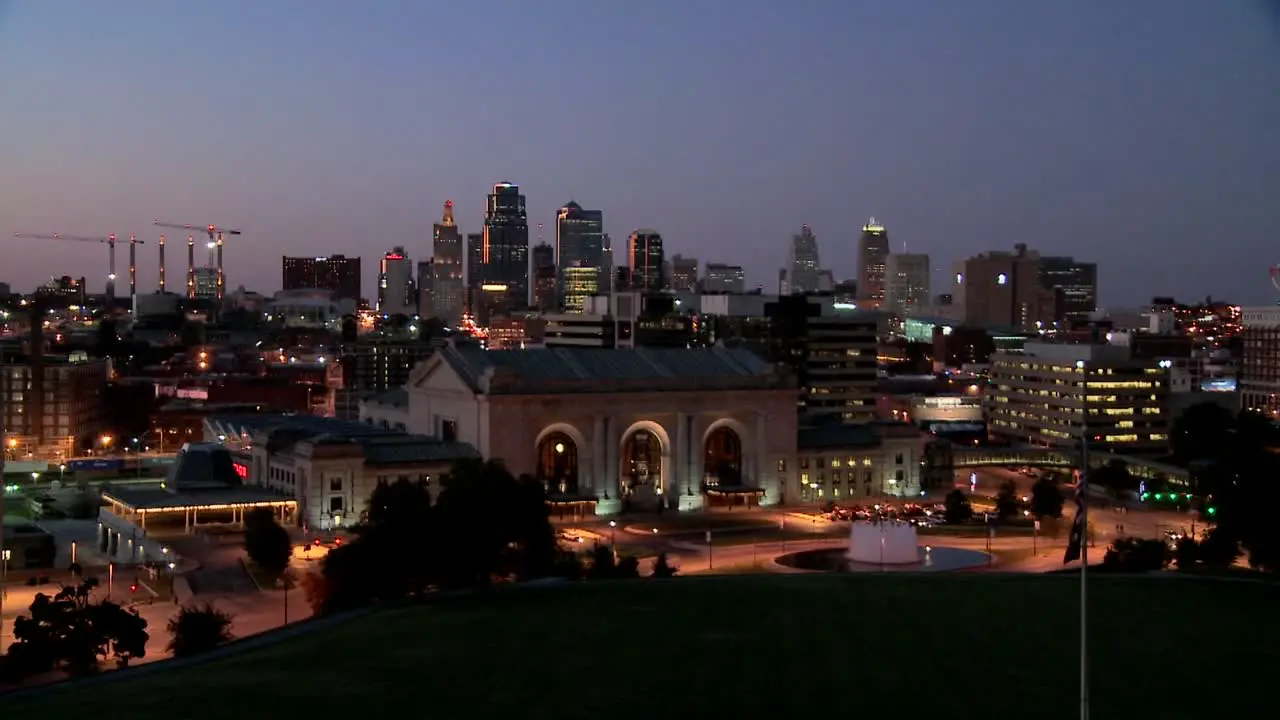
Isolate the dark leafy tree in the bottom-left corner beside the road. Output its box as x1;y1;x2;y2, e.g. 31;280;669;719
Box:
5;579;148;676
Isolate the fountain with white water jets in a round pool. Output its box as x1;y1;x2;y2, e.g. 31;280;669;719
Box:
776;520;991;573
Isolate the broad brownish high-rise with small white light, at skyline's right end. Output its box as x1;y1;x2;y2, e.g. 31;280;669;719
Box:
951;243;1055;332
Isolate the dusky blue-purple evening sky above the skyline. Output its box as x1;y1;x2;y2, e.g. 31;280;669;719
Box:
0;0;1280;306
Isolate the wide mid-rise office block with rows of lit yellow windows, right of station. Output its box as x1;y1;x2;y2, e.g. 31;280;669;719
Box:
987;342;1171;455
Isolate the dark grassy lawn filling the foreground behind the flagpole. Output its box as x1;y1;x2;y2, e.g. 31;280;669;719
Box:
0;573;1280;720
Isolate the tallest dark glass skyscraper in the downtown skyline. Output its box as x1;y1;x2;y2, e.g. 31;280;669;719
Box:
480;182;529;310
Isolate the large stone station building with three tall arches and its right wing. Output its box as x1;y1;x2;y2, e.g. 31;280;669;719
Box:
361;343;924;514
